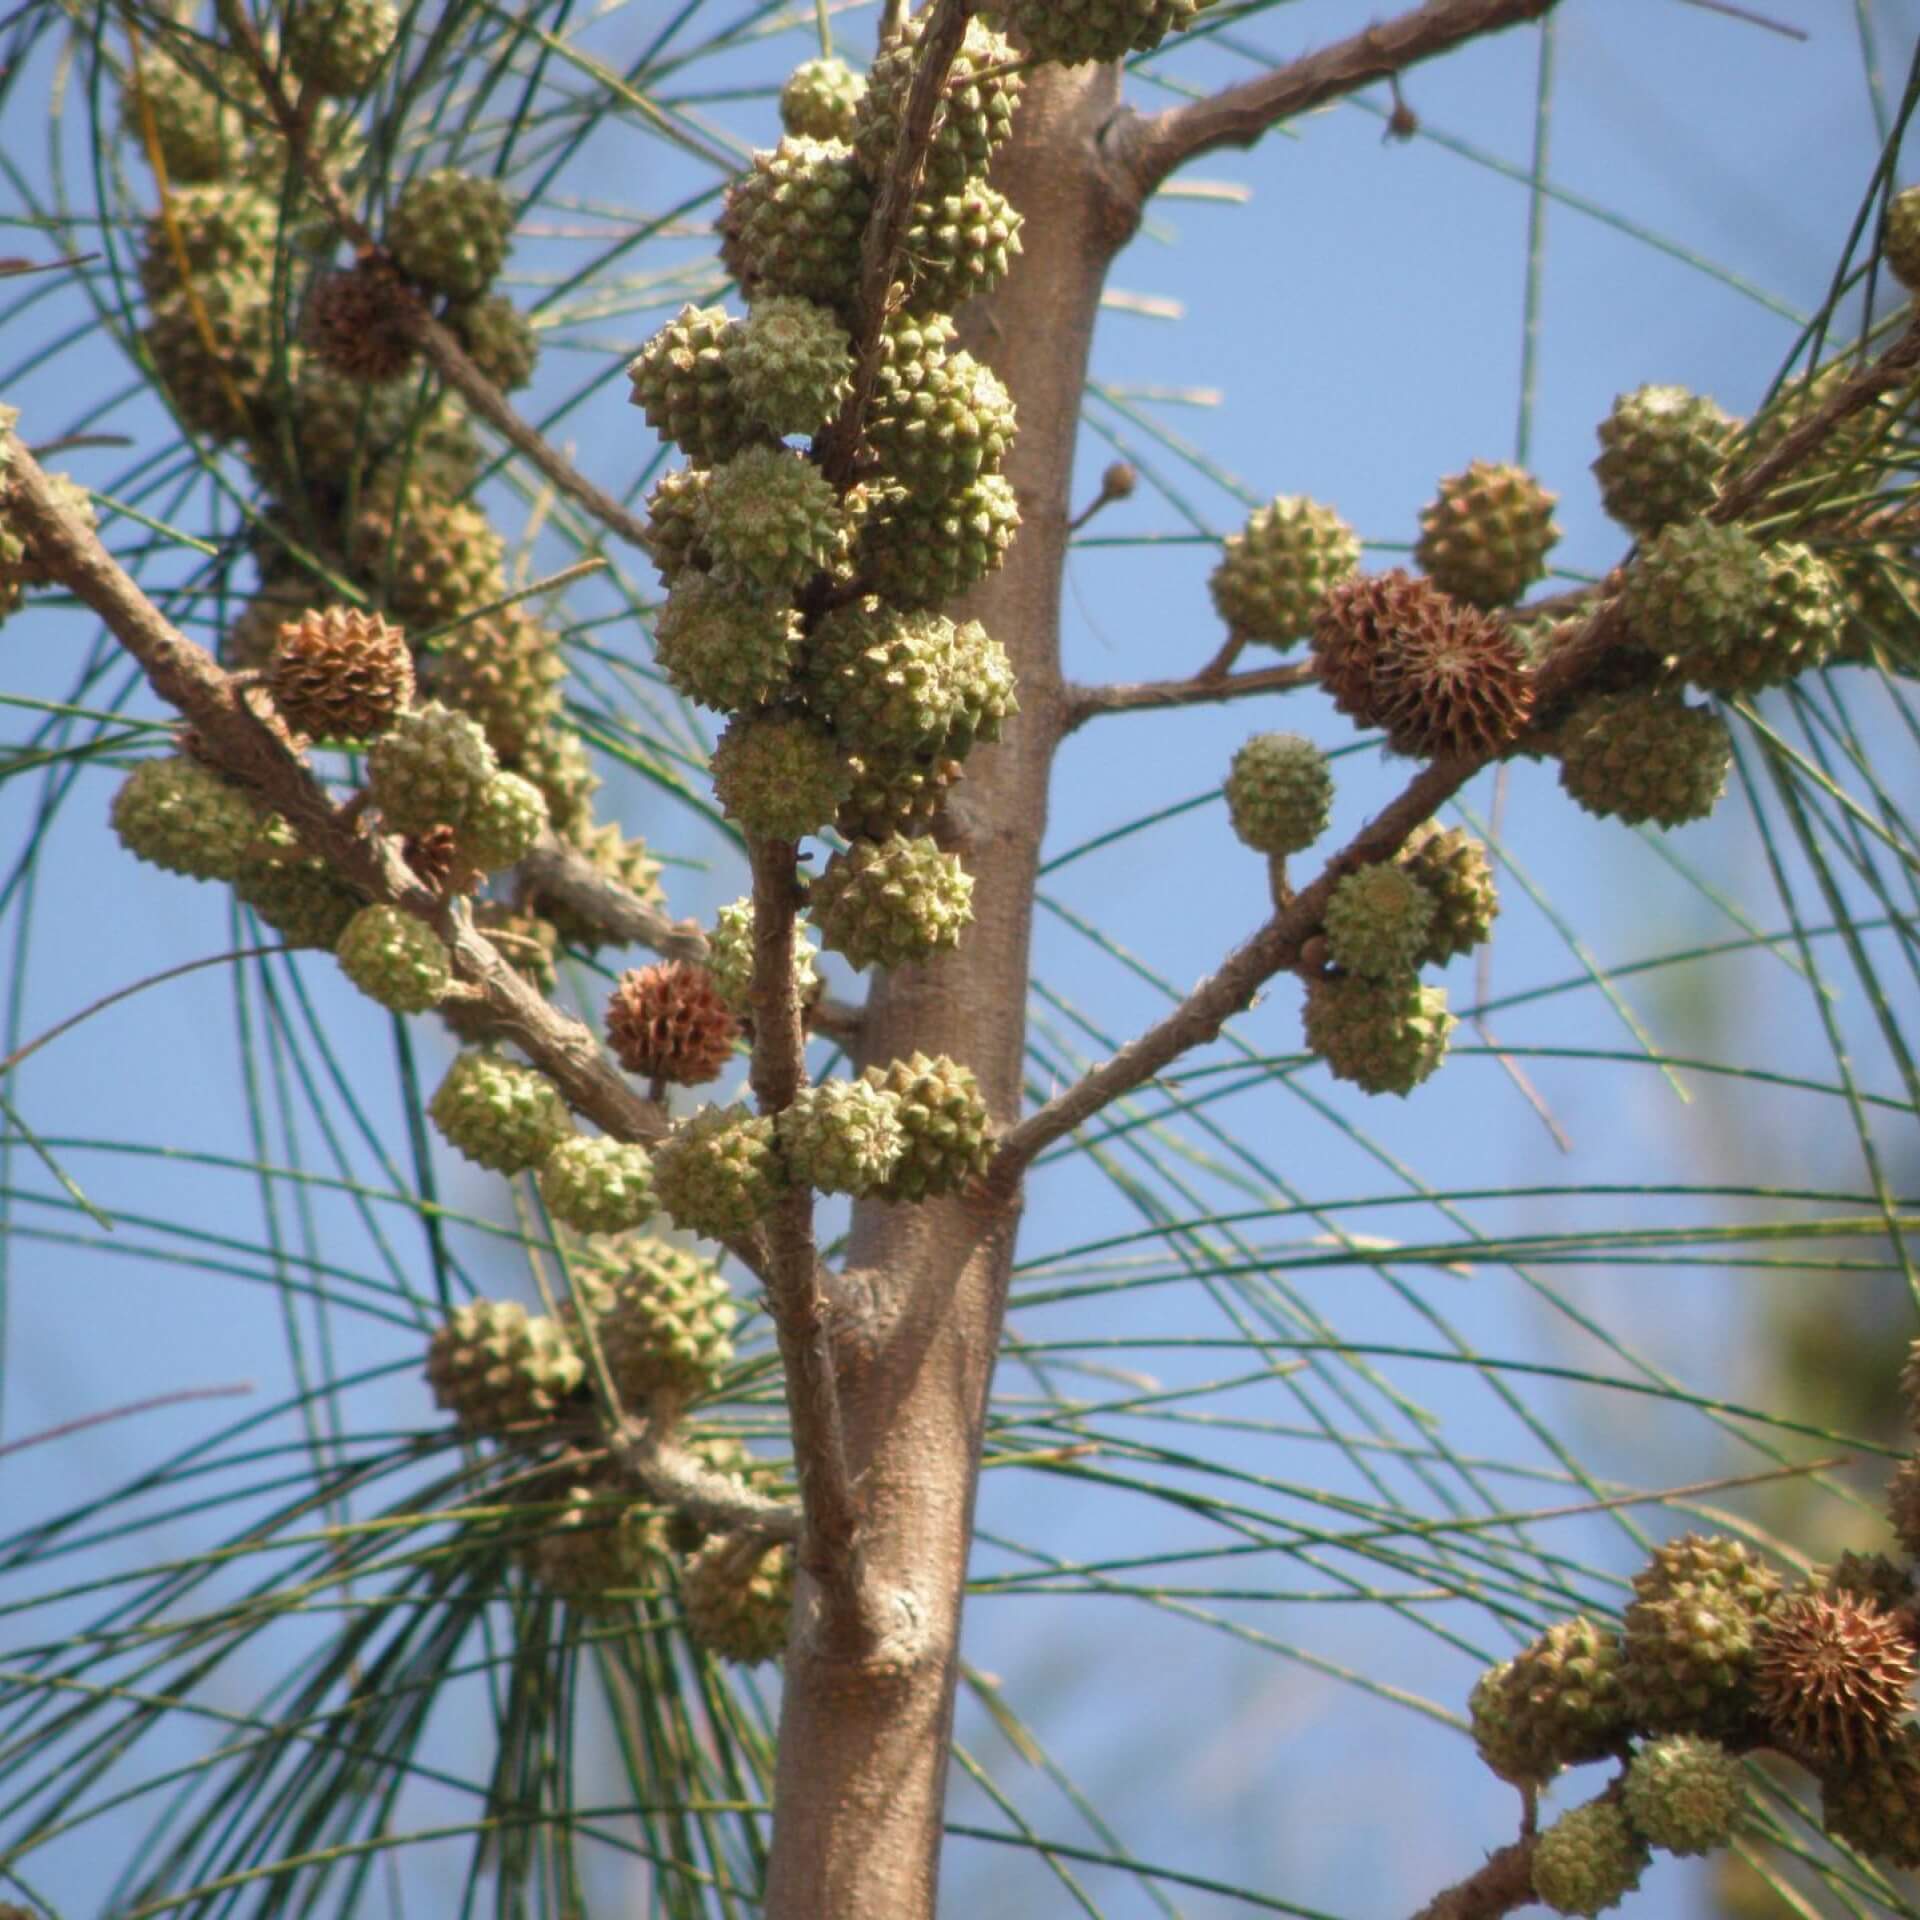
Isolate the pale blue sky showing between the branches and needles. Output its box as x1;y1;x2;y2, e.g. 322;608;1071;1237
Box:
0;0;1920;1920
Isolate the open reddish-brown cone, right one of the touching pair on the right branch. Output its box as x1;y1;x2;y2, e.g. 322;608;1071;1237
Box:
1373;595;1534;760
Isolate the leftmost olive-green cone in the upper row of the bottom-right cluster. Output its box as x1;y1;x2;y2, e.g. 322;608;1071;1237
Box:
1469;1615;1628;1786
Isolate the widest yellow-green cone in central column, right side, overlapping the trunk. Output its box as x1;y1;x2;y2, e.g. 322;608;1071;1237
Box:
804;599;1020;760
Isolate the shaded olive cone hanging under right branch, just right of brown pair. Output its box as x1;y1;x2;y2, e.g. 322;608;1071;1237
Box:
1557;693;1734;828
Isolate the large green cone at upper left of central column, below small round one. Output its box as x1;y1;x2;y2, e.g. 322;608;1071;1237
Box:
720;134;874;315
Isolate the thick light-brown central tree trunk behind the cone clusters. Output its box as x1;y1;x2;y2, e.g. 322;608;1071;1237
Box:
766;67;1125;1920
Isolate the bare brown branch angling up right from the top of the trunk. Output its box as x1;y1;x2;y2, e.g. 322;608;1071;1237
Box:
1106;0;1557;204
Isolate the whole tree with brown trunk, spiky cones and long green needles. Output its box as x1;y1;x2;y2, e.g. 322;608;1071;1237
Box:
4;0;1920;1916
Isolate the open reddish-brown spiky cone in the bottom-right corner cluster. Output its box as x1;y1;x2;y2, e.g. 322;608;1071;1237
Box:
1753;1592;1914;1766
